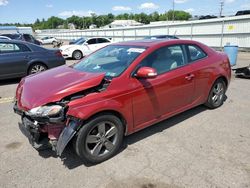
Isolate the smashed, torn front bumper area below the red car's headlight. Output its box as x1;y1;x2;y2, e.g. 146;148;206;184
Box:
13;104;81;156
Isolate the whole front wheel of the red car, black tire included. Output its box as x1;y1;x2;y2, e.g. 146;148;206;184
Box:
74;114;124;164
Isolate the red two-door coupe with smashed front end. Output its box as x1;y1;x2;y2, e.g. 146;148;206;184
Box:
14;40;231;163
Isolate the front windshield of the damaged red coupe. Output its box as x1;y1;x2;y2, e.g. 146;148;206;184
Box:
73;45;146;78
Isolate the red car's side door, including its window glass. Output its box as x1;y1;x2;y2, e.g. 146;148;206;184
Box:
132;45;194;128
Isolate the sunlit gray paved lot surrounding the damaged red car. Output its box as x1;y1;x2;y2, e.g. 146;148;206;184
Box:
0;53;250;188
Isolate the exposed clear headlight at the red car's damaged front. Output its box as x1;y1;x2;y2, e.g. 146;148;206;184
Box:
26;105;63;117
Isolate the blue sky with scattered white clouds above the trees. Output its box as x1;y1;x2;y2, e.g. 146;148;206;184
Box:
0;0;250;23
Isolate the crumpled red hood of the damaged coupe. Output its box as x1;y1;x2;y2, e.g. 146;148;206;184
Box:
16;66;105;110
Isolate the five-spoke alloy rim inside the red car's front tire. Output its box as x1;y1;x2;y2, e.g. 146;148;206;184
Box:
85;121;118;157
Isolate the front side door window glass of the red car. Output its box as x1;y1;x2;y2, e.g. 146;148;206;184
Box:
140;45;185;74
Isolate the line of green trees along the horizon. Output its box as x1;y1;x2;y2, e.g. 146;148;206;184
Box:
0;10;192;30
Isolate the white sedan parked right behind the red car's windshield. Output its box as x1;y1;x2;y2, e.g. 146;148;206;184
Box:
60;37;111;60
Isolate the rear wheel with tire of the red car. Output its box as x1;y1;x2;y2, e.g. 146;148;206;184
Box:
205;79;226;109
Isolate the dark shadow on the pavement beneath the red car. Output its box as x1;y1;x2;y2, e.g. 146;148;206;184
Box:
39;105;207;169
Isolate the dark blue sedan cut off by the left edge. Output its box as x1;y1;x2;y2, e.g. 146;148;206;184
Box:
0;40;65;80
